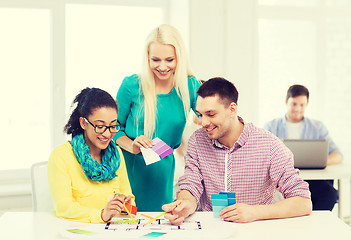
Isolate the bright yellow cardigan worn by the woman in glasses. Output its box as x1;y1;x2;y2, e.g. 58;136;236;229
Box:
48;142;135;223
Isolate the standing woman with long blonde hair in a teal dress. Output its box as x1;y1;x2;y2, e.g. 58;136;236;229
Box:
114;25;200;211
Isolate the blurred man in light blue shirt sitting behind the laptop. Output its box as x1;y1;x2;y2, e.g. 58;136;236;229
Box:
264;85;343;211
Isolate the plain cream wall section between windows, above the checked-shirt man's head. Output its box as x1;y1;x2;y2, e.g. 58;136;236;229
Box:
189;0;258;122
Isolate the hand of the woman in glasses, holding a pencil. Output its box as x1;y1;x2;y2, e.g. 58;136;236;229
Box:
101;193;131;222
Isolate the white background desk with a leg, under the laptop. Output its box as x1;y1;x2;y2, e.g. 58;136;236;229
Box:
300;163;351;222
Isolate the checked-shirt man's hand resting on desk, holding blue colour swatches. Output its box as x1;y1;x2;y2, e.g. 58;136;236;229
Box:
219;203;257;223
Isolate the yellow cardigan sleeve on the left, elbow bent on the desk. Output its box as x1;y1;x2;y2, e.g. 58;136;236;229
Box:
48;144;103;223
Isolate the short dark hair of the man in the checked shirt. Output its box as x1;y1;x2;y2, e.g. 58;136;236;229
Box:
197;77;239;106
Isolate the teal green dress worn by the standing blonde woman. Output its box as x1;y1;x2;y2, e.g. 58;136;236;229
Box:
114;74;200;212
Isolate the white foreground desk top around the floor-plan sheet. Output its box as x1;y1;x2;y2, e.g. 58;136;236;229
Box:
0;211;351;240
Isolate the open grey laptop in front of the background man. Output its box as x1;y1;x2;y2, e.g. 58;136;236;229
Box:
283;139;329;169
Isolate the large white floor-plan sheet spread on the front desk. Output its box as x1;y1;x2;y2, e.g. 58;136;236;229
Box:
59;212;236;240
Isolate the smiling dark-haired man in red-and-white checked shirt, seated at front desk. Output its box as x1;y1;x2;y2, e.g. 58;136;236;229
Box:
163;78;312;225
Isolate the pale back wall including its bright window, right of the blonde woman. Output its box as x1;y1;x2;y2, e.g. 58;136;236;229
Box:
189;0;351;161
